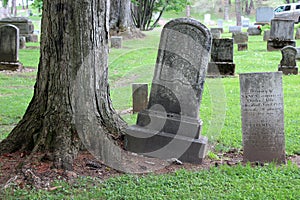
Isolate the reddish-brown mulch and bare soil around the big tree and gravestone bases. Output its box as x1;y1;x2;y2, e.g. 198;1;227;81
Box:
0;150;300;190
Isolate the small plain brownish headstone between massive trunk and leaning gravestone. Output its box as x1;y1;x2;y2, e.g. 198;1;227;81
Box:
132;83;148;113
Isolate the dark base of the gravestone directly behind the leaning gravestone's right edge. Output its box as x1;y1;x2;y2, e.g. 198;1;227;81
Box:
207;62;235;76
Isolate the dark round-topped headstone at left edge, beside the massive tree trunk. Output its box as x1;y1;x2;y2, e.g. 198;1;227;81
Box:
0;25;21;70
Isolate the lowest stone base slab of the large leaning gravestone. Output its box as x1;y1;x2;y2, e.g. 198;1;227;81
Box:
125;125;208;164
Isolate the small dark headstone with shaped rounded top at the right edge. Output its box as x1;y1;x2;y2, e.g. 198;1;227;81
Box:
278;46;298;75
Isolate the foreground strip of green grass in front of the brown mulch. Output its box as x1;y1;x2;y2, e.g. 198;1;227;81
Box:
4;164;300;200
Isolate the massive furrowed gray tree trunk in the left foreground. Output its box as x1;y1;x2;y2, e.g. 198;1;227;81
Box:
0;0;125;170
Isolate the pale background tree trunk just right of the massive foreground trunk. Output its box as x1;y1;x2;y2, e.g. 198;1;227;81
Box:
109;0;144;38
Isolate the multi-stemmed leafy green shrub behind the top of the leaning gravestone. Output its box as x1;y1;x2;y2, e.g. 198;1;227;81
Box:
132;0;187;31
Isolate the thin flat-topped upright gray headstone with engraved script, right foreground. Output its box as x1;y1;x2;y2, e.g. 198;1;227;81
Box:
239;72;285;163
